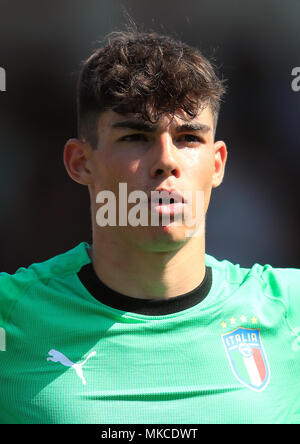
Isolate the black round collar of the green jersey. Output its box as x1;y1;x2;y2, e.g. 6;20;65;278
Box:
78;263;212;316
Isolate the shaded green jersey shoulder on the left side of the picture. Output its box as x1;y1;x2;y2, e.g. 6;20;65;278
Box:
0;242;90;327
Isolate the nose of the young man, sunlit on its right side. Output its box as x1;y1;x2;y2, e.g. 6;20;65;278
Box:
151;133;180;177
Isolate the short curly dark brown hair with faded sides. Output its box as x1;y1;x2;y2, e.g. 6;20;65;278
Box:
77;31;225;148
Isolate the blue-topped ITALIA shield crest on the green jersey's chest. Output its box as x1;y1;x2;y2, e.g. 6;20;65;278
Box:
222;327;270;391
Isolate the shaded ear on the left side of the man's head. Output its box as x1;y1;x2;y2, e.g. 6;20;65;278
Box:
64;139;91;185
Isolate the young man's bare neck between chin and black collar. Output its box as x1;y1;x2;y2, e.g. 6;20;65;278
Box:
90;231;205;300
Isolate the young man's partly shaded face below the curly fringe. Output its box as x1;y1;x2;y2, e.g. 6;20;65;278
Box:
83;107;226;251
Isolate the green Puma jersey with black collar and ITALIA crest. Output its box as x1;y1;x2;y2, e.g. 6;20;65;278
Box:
0;242;300;424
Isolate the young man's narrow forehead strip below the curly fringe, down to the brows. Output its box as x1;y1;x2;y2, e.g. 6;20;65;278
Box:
98;106;214;134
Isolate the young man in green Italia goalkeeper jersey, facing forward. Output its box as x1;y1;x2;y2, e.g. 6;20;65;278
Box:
0;32;300;424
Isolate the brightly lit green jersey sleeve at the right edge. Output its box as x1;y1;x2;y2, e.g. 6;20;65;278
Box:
262;265;300;329
